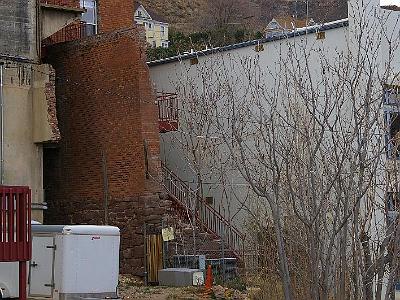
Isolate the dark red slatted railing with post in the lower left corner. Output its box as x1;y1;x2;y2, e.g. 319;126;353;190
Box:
0;186;32;300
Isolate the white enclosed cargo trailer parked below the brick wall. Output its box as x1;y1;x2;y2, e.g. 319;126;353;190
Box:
0;225;120;300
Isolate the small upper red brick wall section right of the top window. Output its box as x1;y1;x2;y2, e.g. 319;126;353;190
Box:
97;0;134;32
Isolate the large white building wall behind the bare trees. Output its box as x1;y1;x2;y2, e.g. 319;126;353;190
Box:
148;0;400;299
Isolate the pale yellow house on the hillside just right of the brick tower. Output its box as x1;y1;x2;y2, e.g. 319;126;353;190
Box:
135;2;169;48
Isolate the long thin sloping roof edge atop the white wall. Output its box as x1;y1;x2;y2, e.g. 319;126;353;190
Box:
147;18;349;67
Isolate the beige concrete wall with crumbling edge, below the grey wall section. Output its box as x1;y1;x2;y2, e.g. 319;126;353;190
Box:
3;63;54;222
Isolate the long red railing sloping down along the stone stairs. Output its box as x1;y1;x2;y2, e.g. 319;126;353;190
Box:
162;164;246;258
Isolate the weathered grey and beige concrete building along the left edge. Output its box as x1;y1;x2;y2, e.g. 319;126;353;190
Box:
0;0;83;222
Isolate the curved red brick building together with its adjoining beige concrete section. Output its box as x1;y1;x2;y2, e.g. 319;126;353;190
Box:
0;0;169;276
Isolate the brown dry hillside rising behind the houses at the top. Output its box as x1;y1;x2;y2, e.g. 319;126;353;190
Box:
140;0;347;32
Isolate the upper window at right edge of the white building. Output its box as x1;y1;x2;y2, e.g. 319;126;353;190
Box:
384;86;400;159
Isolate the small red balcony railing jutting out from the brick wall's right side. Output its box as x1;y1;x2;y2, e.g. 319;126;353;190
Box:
157;92;178;132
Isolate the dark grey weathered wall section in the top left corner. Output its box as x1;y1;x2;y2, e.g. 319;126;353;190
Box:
0;0;37;59
